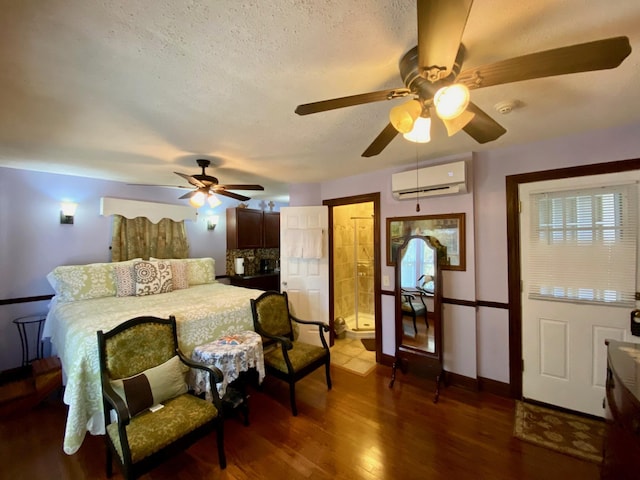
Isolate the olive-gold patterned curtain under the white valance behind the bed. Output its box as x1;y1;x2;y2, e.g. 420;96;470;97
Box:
111;215;189;262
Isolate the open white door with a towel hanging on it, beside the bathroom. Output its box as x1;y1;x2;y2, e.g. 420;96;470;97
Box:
280;206;329;345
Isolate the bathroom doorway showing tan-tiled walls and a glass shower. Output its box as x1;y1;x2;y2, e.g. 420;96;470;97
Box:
324;193;382;361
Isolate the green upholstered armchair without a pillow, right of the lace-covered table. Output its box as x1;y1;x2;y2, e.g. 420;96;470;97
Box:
251;291;331;416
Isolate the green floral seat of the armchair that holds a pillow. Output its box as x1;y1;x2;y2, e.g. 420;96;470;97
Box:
107;394;218;463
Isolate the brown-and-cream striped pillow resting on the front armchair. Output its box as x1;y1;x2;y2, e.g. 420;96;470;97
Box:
111;355;188;416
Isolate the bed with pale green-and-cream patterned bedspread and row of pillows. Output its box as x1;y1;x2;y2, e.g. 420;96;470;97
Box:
43;258;261;454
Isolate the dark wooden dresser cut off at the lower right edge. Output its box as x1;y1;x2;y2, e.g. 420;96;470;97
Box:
602;340;640;480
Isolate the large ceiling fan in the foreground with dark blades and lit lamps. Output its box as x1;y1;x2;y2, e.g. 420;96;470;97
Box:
295;0;631;157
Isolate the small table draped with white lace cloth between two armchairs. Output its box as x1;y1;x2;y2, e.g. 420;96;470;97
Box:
191;330;264;400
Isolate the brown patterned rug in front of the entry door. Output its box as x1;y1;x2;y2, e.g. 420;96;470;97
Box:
513;402;605;463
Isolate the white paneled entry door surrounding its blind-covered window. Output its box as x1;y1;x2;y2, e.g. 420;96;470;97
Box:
519;172;640;417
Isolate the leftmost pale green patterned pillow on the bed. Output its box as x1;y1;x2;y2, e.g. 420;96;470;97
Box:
47;263;116;302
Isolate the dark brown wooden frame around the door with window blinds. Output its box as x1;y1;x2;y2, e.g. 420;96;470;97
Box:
506;158;640;398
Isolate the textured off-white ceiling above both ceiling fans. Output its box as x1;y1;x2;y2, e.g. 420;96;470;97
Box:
0;0;640;199
